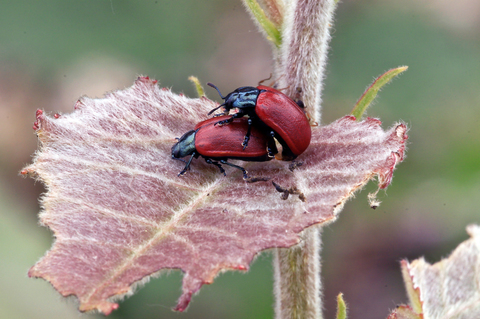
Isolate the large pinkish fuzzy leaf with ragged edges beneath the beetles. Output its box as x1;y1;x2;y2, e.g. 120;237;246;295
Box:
22;77;406;314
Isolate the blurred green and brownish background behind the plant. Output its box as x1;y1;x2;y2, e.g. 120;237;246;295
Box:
0;0;480;319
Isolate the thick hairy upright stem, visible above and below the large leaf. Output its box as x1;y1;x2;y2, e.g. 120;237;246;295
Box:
274;0;336;319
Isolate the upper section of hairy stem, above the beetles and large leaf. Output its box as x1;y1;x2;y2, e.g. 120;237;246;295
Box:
275;0;336;122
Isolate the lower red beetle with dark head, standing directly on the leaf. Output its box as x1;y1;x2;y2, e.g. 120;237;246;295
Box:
172;116;272;179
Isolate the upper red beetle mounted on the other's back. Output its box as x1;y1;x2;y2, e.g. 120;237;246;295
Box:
208;83;312;160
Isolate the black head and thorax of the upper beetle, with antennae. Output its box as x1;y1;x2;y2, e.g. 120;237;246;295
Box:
208;83;260;115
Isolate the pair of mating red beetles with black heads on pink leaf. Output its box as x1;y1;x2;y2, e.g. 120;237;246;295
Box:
172;83;311;179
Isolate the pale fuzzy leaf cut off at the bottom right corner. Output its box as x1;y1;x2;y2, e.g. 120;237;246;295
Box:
402;225;480;319
